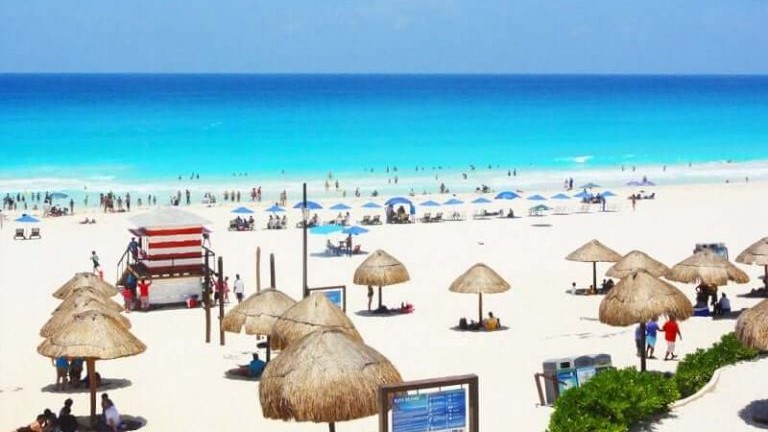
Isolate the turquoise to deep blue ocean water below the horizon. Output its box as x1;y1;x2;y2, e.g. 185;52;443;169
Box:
0;75;768;201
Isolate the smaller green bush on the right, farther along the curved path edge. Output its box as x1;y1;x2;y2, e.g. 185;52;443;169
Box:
675;333;759;397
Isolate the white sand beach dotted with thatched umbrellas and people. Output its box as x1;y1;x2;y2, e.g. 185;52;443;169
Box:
0;181;768;432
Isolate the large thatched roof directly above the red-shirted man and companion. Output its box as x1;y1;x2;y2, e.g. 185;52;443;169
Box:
600;269;693;326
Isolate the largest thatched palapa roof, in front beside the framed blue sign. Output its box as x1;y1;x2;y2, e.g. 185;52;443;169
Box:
259;330;402;423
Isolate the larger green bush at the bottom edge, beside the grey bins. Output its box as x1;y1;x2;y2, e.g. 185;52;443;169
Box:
549;368;680;432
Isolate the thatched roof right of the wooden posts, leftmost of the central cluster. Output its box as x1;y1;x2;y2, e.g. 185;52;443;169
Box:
222;288;296;336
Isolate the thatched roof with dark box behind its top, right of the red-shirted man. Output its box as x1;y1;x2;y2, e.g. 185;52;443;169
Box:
666;250;749;285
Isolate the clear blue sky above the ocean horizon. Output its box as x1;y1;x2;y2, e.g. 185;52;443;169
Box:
0;0;768;74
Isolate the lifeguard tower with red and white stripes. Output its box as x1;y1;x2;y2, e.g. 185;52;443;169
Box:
117;207;215;305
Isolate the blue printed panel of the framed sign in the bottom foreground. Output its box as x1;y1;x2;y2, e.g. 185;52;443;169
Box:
392;389;467;432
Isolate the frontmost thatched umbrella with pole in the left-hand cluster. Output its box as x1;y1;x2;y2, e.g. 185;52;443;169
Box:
37;310;147;418
